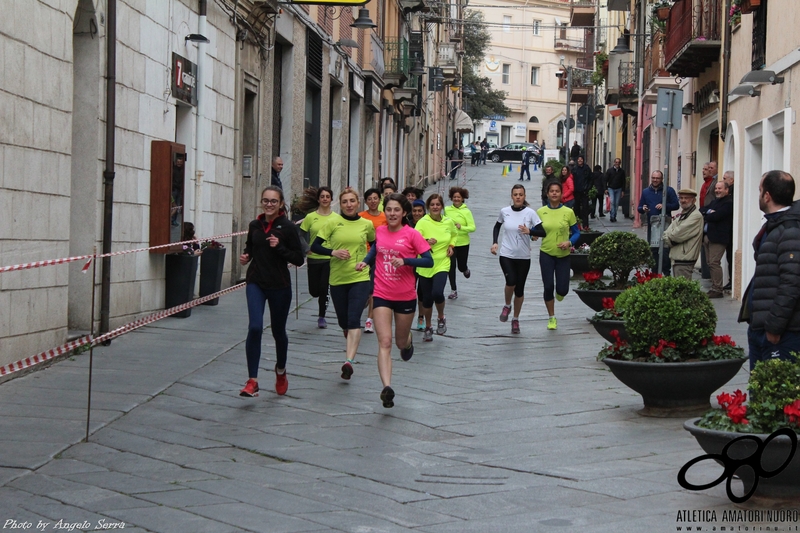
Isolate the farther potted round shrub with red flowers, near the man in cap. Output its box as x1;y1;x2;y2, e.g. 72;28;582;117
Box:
575;231;653;311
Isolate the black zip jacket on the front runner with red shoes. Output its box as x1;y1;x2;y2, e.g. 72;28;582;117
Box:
244;214;304;289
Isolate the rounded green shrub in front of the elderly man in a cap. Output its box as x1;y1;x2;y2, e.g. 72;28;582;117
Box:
589;231;653;289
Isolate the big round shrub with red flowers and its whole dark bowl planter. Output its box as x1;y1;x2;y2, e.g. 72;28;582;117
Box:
597;278;746;416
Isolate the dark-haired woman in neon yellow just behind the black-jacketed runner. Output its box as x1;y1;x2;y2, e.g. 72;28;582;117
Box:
298;187;339;329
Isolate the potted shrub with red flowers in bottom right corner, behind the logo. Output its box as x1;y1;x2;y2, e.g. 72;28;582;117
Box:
684;359;800;502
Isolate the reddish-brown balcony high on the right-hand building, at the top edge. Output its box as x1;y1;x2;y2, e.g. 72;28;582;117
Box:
664;0;724;78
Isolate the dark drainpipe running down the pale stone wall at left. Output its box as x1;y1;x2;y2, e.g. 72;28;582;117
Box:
99;0;117;336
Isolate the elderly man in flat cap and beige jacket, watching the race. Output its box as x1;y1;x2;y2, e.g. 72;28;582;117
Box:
663;189;703;280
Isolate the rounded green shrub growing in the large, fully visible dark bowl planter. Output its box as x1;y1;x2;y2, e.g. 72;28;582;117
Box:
620;276;717;354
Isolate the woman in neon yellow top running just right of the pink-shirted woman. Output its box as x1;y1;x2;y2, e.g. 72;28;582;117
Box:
415;194;458;342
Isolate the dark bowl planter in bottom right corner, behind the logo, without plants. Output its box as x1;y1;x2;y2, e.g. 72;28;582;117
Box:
683;418;800;500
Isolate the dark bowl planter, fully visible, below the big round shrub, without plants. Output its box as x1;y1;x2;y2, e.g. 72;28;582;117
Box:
603;357;747;417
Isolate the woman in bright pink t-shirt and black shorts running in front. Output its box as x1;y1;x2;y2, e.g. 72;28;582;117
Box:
356;193;433;408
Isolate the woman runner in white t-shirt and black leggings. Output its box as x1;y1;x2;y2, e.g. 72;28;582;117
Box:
491;184;544;334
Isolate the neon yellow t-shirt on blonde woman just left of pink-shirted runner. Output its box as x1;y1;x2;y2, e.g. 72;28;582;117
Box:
317;216;375;286
